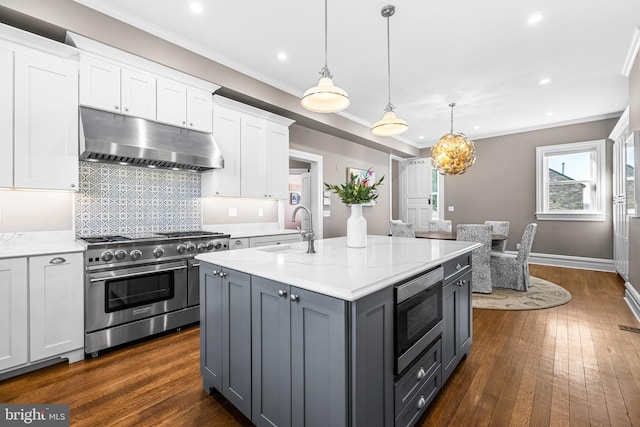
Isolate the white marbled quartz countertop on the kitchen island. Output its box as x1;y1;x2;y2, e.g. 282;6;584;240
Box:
196;235;480;301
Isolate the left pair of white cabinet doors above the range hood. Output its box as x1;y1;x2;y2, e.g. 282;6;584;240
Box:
79;55;156;120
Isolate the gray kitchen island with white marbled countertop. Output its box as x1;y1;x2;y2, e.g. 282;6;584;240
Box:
196;236;478;426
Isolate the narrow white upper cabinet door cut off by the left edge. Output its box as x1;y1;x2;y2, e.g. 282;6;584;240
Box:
0;49;13;188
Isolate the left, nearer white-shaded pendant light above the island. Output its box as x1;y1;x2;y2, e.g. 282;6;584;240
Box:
300;0;351;113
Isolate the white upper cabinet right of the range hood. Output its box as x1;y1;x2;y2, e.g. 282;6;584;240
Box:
202;96;293;199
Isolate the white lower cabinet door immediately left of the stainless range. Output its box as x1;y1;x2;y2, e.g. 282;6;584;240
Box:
29;253;84;361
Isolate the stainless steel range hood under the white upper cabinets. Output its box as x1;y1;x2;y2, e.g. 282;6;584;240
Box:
80;107;224;172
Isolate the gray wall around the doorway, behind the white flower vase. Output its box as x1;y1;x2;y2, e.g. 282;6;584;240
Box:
289;123;389;238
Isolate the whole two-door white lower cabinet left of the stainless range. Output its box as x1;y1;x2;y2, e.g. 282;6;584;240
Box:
0;252;84;372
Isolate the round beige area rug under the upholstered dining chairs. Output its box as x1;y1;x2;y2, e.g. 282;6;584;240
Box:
473;276;571;310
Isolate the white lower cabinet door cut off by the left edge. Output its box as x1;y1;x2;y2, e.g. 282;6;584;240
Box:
0;258;29;372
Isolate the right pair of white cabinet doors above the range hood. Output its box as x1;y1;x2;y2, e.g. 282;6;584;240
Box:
157;79;213;132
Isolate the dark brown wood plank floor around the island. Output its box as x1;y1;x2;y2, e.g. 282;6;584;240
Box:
0;265;640;427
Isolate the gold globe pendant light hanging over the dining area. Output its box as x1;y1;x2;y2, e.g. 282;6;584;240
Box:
431;102;476;175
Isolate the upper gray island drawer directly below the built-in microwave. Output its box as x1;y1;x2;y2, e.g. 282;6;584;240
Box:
394;338;442;415
